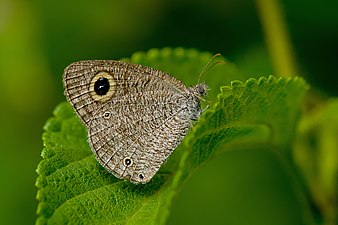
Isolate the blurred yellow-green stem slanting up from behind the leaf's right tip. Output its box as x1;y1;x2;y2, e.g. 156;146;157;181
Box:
256;0;297;77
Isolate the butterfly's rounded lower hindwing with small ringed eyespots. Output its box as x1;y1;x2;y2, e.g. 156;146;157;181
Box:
89;91;191;183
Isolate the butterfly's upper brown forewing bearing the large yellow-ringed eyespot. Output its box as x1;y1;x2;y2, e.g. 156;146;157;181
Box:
63;60;186;125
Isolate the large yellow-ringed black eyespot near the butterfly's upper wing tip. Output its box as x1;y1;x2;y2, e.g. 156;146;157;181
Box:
89;71;116;102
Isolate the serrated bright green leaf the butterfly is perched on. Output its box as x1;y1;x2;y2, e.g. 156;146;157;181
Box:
36;48;306;224
